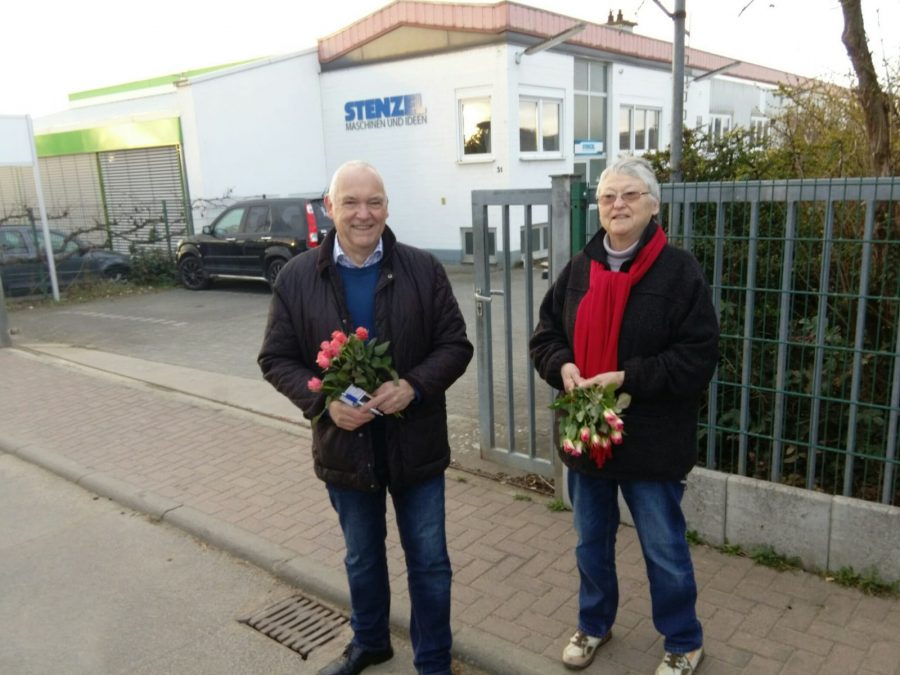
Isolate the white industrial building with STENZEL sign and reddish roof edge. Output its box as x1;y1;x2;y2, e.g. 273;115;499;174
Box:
0;0;798;262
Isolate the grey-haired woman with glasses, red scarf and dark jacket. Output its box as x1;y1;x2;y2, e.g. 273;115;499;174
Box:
530;157;719;675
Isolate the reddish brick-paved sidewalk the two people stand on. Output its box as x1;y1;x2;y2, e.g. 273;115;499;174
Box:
0;345;900;675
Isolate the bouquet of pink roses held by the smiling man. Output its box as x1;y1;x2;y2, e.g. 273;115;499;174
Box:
306;326;399;419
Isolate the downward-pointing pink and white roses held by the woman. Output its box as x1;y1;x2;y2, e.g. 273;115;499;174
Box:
550;385;631;468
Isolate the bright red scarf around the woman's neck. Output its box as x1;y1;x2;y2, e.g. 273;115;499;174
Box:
573;225;667;378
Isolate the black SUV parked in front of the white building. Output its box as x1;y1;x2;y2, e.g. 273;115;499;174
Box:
175;197;334;291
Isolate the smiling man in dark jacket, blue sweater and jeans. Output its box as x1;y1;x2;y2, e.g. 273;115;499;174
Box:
259;161;473;675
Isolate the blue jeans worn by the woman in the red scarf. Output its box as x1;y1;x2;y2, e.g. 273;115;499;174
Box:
569;471;703;654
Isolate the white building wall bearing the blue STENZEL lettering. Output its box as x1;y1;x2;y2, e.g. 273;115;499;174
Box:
321;45;573;256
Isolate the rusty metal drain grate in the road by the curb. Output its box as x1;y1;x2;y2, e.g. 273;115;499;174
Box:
240;594;349;660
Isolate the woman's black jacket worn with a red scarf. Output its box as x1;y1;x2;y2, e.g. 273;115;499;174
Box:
530;220;719;480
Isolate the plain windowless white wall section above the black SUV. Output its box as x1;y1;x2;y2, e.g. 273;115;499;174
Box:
179;51;328;215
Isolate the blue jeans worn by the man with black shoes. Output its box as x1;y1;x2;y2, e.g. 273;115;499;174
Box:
328;475;453;675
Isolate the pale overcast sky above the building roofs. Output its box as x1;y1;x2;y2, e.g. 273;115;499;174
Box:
0;0;900;117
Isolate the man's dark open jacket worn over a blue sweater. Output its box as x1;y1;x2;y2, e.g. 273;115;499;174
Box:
258;227;473;491
